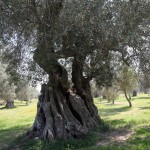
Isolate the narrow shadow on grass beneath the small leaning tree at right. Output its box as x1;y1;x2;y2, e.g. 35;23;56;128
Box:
98;106;132;116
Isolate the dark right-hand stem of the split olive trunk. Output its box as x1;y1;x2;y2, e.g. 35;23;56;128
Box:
72;56;99;122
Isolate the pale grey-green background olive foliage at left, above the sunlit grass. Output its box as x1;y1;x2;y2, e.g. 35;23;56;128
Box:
0;61;38;101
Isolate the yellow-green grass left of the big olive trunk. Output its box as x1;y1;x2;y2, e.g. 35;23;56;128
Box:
0;100;37;149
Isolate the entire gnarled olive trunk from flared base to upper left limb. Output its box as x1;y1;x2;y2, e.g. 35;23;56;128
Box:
27;0;100;141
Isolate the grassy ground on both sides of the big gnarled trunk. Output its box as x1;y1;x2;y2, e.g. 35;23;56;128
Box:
0;94;150;150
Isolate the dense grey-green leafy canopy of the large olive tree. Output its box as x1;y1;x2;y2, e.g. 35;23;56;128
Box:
0;0;150;84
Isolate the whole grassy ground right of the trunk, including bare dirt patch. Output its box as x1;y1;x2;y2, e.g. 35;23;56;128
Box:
82;94;150;150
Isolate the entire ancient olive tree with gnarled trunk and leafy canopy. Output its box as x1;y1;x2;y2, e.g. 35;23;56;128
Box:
0;0;150;140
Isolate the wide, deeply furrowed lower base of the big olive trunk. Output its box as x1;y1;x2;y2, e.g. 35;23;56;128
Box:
28;61;100;140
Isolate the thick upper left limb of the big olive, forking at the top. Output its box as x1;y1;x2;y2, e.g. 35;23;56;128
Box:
31;0;63;73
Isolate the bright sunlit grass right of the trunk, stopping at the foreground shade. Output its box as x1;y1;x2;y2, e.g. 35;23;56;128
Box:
95;94;150;128
